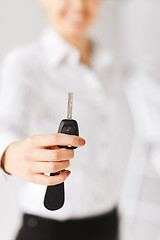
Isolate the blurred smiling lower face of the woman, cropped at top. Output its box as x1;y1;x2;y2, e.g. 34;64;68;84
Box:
40;0;101;37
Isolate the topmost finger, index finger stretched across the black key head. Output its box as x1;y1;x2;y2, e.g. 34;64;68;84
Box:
29;133;85;147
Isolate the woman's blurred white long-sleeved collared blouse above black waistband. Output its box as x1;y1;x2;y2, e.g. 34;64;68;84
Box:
0;28;133;220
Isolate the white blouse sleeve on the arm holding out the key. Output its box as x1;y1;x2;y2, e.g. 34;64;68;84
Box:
0;50;35;180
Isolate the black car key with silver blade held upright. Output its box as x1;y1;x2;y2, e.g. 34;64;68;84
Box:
44;93;79;210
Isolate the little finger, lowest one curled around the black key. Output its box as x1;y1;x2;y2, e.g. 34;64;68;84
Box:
30;170;70;186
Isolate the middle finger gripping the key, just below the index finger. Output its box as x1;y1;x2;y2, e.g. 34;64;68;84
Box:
28;148;74;162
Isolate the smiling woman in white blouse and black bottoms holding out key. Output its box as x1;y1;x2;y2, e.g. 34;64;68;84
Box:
0;0;131;240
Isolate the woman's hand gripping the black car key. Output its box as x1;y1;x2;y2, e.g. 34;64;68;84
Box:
2;133;85;186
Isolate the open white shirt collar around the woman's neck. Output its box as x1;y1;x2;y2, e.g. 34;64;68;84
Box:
40;27;113;71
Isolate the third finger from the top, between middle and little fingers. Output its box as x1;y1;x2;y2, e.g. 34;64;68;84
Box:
32;160;70;173
